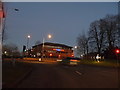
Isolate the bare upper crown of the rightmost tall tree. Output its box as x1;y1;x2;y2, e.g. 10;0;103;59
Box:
104;15;120;49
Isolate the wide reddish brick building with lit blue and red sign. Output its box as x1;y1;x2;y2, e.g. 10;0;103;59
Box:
25;42;74;58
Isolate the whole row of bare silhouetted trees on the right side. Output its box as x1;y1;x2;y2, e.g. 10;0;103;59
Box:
77;15;120;59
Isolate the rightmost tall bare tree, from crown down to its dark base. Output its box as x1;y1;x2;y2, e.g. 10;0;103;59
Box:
101;15;120;59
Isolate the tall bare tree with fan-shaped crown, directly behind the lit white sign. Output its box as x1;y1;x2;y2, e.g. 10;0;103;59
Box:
89;19;105;54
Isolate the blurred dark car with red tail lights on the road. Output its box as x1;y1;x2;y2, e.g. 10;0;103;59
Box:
60;57;80;65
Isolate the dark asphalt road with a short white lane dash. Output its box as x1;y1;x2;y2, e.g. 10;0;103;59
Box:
17;63;118;88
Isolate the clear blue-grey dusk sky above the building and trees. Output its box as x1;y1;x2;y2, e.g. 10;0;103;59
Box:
5;2;118;50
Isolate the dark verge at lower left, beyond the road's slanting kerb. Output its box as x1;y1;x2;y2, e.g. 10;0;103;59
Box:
2;60;34;88
